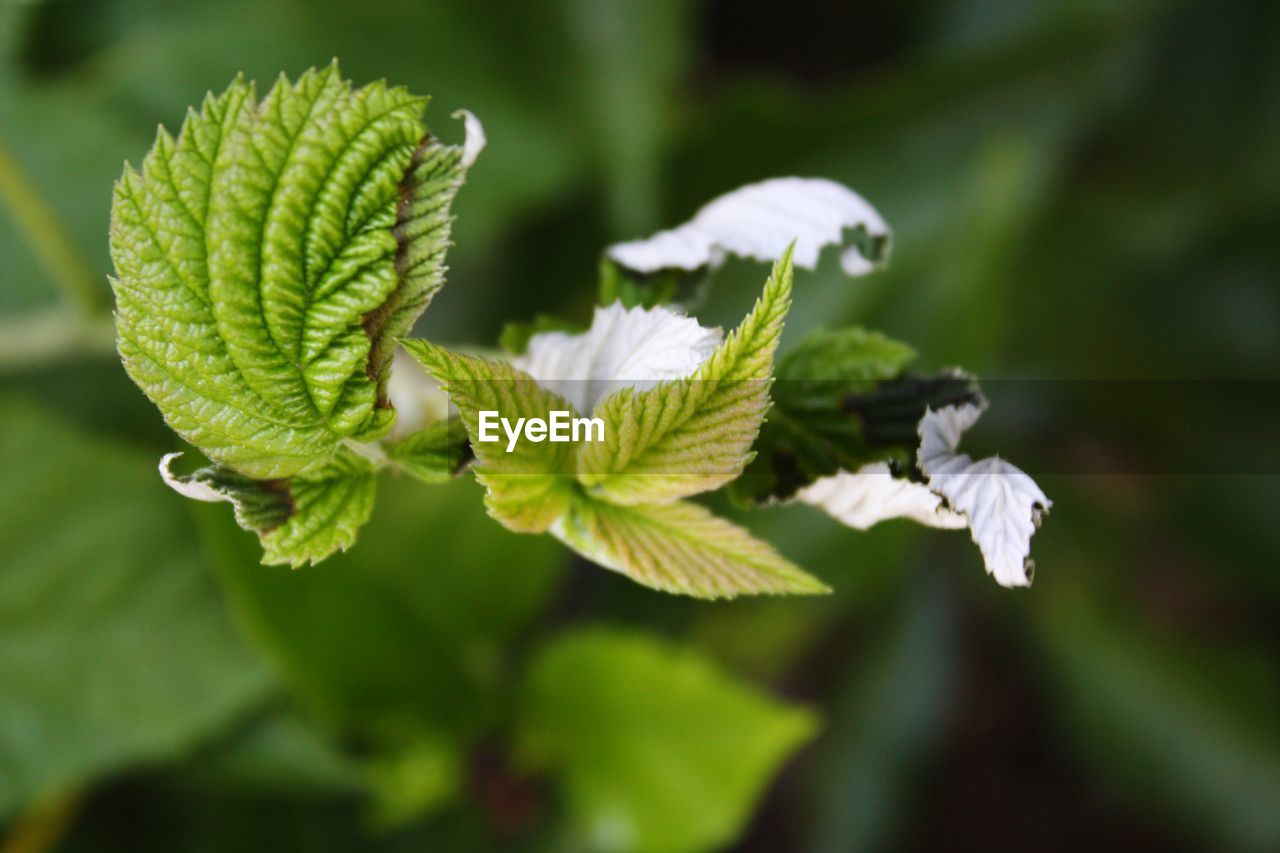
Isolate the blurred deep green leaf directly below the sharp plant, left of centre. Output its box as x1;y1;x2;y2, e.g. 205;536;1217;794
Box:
193;478;563;743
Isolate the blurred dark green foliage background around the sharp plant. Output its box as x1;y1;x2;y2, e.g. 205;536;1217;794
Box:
0;0;1280;853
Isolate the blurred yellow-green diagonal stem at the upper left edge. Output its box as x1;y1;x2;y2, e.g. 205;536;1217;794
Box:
0;142;106;316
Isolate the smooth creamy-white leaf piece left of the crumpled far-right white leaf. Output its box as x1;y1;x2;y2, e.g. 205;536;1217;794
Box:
796;462;968;530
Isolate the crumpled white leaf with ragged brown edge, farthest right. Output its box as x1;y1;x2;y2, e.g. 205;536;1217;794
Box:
918;403;1052;587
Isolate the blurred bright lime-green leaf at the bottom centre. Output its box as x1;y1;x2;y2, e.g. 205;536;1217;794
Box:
520;629;817;852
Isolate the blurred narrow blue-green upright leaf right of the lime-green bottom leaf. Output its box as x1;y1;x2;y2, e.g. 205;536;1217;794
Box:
808;573;955;852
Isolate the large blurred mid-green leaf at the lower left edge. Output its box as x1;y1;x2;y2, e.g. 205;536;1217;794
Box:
0;401;270;815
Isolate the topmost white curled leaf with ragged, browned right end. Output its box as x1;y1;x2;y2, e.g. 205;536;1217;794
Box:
607;178;890;275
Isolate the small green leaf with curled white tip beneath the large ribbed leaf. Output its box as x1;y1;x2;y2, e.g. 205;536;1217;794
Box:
160;448;375;569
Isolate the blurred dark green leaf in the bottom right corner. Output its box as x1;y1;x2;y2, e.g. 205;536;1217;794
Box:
1036;573;1280;852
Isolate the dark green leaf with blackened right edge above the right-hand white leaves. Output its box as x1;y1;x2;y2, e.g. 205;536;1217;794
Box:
730;327;978;503
